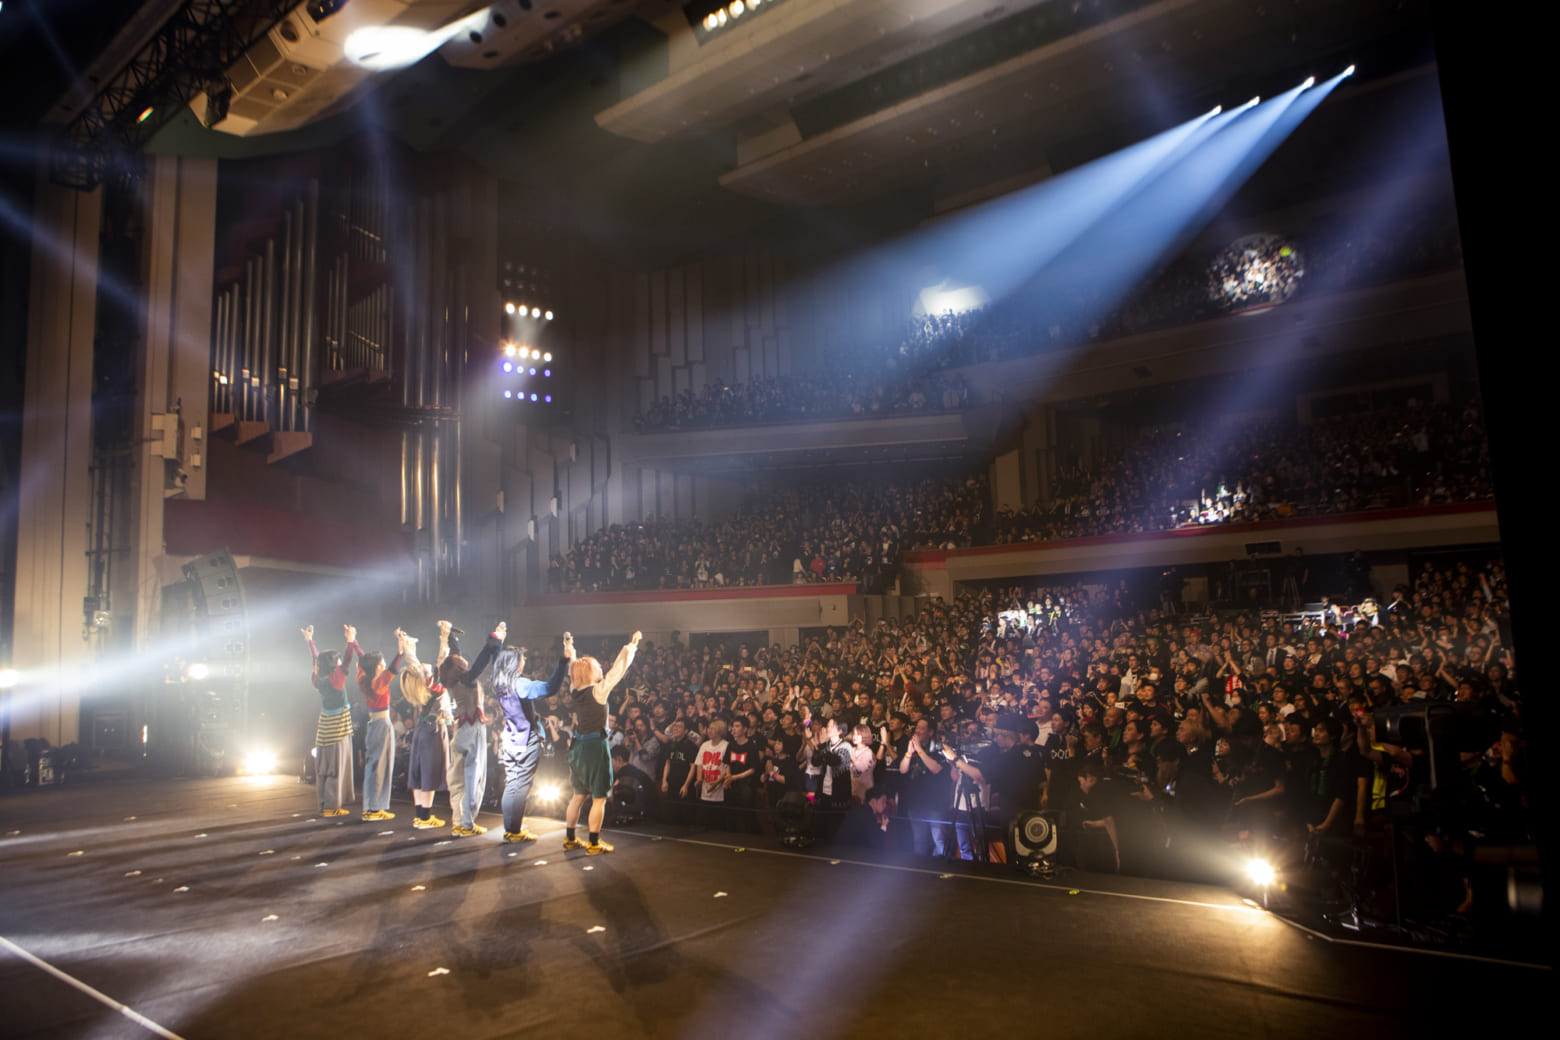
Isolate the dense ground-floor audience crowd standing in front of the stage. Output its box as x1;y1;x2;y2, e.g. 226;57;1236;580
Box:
396;560;1530;907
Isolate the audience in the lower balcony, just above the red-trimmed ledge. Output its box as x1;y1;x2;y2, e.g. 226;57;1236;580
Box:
546;402;1493;593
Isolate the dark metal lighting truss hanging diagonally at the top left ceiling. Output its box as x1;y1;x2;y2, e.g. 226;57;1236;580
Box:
50;0;298;192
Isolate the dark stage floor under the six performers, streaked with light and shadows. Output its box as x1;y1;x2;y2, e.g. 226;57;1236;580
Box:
0;778;1551;1040
